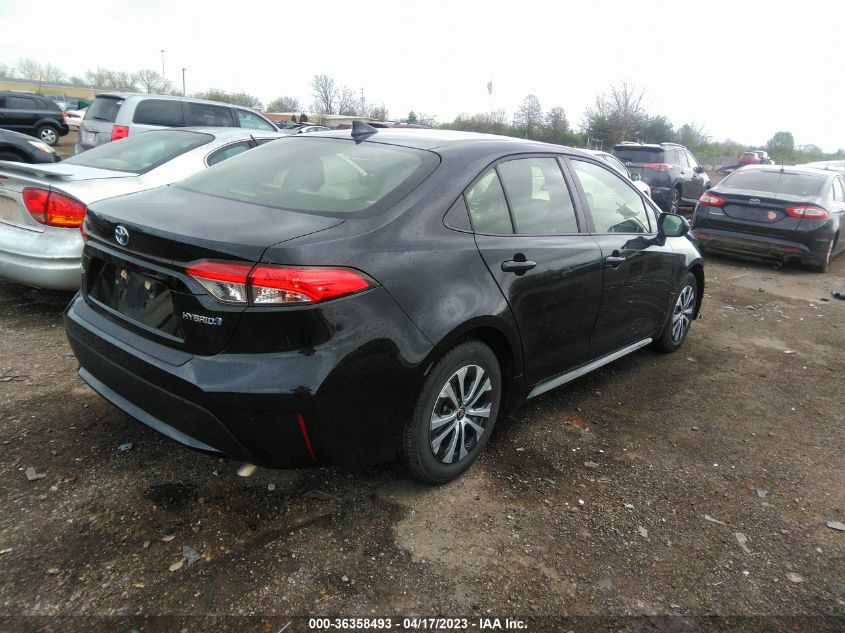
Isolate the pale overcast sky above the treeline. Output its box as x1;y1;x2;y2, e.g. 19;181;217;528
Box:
0;0;845;152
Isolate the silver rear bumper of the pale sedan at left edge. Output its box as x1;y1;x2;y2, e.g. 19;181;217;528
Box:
0;223;82;290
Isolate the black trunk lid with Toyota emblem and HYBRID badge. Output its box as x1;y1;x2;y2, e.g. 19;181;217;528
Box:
83;187;343;355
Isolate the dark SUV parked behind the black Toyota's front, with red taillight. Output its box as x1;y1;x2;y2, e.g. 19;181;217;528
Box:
613;142;710;213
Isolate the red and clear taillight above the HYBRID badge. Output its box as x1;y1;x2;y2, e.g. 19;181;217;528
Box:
186;261;373;305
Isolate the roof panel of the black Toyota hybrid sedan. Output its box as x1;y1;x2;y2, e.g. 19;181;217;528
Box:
308;128;589;156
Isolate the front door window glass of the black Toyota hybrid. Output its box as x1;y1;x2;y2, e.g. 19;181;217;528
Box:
571;160;652;233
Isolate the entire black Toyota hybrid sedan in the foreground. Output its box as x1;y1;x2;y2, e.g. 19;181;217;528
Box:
65;125;704;483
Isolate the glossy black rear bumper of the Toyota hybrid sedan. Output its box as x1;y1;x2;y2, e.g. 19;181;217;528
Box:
64;293;432;468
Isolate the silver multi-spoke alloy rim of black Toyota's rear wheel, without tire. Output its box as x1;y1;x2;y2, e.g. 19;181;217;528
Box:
429;365;493;464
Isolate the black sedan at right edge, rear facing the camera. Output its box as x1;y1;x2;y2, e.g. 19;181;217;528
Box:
693;165;845;272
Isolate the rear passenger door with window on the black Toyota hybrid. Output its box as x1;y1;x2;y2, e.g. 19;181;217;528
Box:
465;156;603;385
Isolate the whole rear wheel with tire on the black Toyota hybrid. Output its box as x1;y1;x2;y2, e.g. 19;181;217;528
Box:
402;341;502;484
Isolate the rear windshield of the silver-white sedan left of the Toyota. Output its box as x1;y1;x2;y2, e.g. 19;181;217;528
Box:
62;130;214;174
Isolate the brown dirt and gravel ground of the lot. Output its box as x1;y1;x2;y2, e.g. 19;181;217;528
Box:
0;244;845;632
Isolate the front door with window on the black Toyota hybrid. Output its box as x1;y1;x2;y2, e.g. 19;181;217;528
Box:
567;158;681;358
